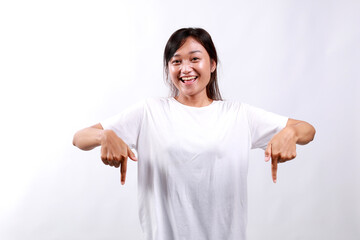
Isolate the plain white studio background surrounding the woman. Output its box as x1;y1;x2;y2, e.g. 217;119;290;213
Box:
0;0;360;240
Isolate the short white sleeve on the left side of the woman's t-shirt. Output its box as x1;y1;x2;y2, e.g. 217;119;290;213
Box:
100;102;145;149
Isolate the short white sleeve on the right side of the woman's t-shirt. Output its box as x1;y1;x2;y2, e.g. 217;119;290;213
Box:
245;105;288;150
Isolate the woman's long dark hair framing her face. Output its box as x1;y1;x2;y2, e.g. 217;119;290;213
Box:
164;28;222;100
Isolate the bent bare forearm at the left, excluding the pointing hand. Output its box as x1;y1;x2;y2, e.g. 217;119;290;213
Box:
73;127;104;150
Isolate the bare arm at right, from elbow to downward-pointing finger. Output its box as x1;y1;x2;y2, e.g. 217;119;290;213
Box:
265;118;315;183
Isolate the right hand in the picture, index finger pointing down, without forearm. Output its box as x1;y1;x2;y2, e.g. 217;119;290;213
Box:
265;126;297;183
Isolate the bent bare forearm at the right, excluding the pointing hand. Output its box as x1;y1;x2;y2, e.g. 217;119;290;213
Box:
286;119;315;145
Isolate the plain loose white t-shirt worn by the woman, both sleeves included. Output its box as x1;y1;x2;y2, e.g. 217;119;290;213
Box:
101;98;287;240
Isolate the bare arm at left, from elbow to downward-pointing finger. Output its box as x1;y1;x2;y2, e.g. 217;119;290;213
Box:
73;123;137;184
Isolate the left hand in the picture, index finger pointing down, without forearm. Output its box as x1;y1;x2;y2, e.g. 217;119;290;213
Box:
101;130;137;185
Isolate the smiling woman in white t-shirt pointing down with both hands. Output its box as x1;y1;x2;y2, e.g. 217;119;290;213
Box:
73;28;315;240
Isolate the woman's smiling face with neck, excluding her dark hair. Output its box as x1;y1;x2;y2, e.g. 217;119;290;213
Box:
168;37;216;99
